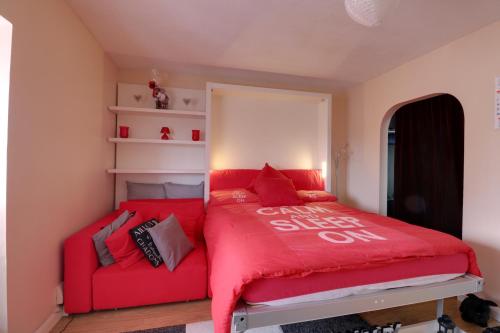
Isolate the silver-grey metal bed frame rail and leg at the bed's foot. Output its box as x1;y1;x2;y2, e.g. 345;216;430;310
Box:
231;274;483;333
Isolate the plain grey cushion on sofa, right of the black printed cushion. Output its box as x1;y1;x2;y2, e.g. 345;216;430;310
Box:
147;214;193;272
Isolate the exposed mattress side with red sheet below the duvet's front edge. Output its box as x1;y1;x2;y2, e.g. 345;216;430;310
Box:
241;253;469;305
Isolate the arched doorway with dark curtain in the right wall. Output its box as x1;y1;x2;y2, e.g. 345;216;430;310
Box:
386;94;464;238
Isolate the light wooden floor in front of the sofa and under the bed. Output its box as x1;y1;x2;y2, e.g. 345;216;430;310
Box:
52;298;500;333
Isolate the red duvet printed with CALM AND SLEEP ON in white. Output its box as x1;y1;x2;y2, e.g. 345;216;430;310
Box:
204;202;481;333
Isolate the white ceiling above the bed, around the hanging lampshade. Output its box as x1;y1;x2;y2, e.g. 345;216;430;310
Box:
67;0;500;88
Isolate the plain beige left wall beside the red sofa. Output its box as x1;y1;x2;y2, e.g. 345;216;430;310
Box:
0;0;116;333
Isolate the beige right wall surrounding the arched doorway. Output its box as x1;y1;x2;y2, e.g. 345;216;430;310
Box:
347;22;500;300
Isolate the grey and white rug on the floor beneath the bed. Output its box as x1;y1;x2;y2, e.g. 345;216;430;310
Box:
126;315;370;333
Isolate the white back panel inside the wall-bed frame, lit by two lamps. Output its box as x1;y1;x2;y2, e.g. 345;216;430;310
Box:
210;91;327;169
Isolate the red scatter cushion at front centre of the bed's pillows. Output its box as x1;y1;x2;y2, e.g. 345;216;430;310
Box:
255;178;303;207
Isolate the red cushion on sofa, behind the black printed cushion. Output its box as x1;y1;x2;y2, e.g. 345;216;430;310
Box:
104;212;144;268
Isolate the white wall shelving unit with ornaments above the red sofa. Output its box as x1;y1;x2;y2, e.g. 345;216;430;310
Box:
111;83;209;207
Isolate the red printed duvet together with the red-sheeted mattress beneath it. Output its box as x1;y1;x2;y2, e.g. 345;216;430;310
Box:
204;170;480;333
